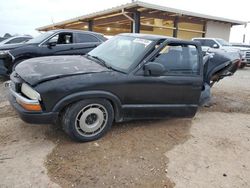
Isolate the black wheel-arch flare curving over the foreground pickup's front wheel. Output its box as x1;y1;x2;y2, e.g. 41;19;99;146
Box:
52;91;122;122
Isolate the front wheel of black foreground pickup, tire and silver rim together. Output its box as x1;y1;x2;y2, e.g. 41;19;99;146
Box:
62;99;114;142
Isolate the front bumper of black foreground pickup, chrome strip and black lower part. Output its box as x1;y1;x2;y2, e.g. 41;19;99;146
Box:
9;88;59;124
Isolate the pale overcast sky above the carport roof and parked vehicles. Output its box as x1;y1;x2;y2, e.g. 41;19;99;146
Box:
0;0;250;43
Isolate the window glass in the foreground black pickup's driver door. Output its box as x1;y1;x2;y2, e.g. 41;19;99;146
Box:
154;44;199;75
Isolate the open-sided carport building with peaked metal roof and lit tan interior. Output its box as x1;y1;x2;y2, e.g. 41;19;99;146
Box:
37;1;245;40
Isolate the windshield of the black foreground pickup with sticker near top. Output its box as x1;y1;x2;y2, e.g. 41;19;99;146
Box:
88;36;152;72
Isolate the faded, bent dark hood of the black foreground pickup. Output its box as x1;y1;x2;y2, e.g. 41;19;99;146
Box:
15;56;111;85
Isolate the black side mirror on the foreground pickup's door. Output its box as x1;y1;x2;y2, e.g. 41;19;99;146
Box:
144;62;165;76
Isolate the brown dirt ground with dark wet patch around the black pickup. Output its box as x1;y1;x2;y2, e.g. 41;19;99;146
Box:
0;68;250;188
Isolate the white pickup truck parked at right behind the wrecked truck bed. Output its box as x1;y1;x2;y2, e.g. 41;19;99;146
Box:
192;38;250;68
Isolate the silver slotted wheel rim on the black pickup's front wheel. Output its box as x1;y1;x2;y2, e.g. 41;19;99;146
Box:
75;104;108;137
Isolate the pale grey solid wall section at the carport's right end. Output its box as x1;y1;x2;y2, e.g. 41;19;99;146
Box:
205;21;231;41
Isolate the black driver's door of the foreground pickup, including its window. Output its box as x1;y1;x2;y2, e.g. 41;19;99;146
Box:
124;41;203;118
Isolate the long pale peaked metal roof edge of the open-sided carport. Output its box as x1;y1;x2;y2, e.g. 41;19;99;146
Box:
37;1;246;31
